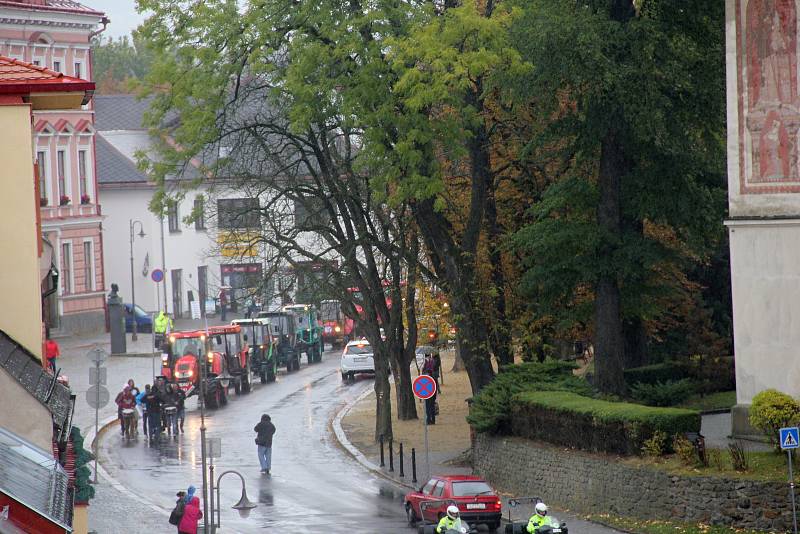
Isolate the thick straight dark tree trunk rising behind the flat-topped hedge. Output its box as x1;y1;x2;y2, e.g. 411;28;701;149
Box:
595;130;625;395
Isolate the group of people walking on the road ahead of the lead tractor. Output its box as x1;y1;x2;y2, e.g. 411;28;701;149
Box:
115;378;186;443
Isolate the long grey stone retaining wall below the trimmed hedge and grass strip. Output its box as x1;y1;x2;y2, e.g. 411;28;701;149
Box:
473;434;792;532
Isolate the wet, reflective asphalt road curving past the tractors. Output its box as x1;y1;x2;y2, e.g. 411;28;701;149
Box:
100;352;414;534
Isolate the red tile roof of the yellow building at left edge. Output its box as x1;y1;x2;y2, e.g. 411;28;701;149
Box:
0;56;94;94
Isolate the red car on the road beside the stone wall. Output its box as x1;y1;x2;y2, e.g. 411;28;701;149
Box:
405;475;502;531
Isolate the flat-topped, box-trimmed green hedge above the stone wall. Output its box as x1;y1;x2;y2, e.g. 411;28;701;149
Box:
511;391;700;455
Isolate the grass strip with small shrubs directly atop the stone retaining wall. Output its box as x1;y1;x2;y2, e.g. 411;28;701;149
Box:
623;449;787;482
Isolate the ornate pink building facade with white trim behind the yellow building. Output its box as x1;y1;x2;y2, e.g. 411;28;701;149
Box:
0;0;108;333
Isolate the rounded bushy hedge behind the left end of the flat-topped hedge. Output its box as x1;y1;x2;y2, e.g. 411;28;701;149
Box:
467;360;592;434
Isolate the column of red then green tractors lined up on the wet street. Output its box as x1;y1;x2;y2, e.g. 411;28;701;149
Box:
161;304;324;408
